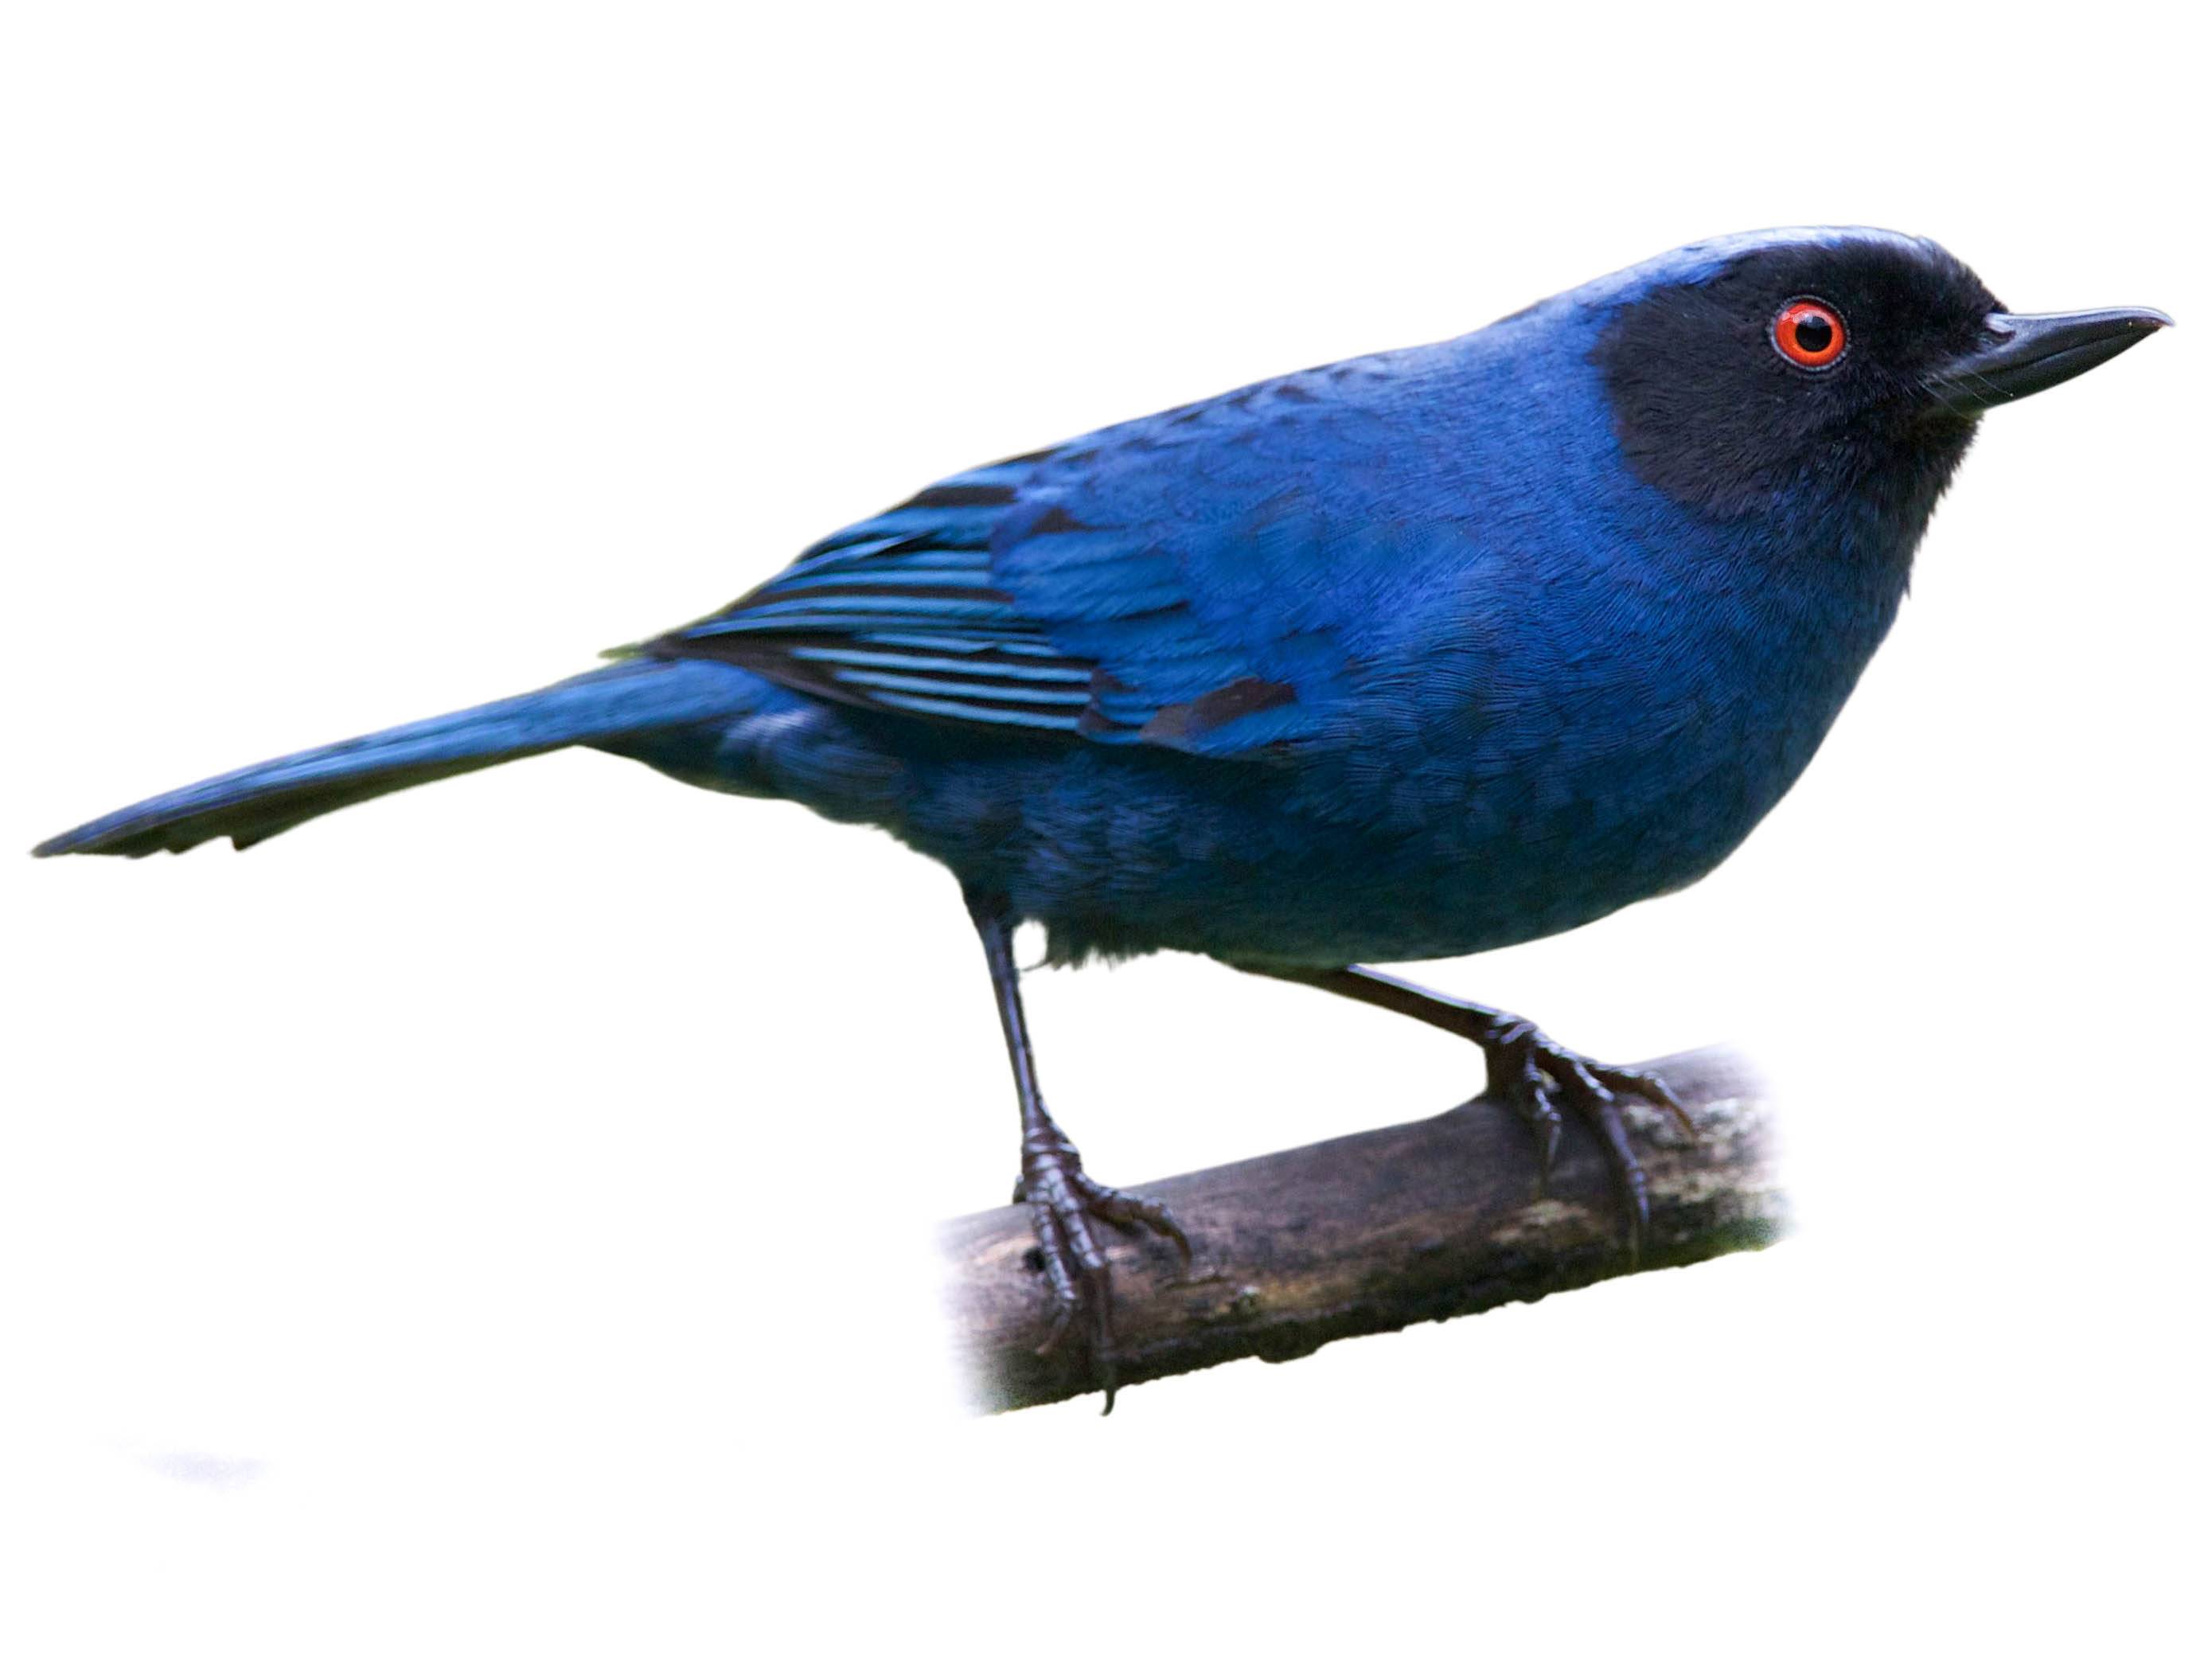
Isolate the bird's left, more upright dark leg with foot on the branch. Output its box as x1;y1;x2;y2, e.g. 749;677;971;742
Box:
966;892;1190;1411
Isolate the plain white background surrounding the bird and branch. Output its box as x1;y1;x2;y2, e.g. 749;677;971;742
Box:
0;5;2212;1654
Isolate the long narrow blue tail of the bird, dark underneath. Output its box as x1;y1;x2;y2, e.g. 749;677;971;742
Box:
33;659;761;858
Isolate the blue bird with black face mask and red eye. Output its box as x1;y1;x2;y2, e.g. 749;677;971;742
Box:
35;225;2172;1411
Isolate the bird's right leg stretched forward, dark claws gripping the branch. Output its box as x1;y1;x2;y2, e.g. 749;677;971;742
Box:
1254;966;1695;1256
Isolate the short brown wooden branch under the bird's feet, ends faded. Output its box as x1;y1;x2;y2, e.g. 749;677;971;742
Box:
940;1048;1787;1411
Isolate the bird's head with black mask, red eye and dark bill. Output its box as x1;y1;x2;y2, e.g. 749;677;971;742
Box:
1584;230;2170;517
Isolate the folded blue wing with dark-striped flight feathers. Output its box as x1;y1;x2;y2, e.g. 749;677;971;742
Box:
642;358;1424;755
